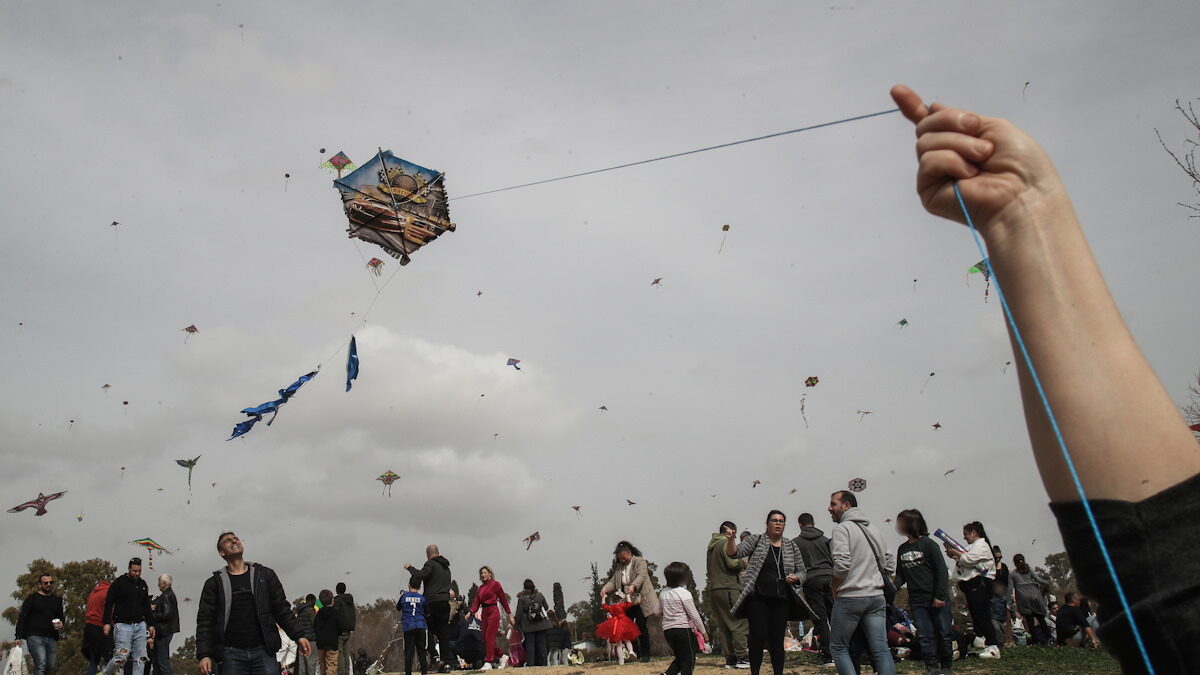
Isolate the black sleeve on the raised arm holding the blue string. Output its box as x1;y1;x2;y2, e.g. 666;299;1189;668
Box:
1050;474;1200;673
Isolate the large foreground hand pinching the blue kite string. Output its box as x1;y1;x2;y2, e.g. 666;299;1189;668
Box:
892;84;1066;234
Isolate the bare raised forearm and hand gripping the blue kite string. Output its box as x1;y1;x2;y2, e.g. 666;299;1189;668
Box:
892;85;1200;502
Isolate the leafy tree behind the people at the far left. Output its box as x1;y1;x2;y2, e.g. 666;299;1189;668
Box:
4;557;116;673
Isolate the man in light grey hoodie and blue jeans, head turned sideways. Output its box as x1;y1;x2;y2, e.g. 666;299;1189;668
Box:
829;490;896;675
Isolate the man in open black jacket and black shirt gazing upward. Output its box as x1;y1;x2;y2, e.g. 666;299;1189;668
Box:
196;532;312;675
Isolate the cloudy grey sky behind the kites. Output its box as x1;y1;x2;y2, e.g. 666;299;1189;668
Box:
0;0;1200;635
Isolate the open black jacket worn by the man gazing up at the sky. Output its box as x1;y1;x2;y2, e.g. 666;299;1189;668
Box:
196;562;305;661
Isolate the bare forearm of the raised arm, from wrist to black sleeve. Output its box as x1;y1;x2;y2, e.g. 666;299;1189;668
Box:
984;190;1200;501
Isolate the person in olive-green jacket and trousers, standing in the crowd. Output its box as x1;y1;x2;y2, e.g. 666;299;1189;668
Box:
704;520;750;670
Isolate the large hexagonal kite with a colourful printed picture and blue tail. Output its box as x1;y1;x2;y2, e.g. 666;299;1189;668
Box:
334;149;455;265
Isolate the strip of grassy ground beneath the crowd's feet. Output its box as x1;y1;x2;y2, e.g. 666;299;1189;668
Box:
472;647;1121;675
